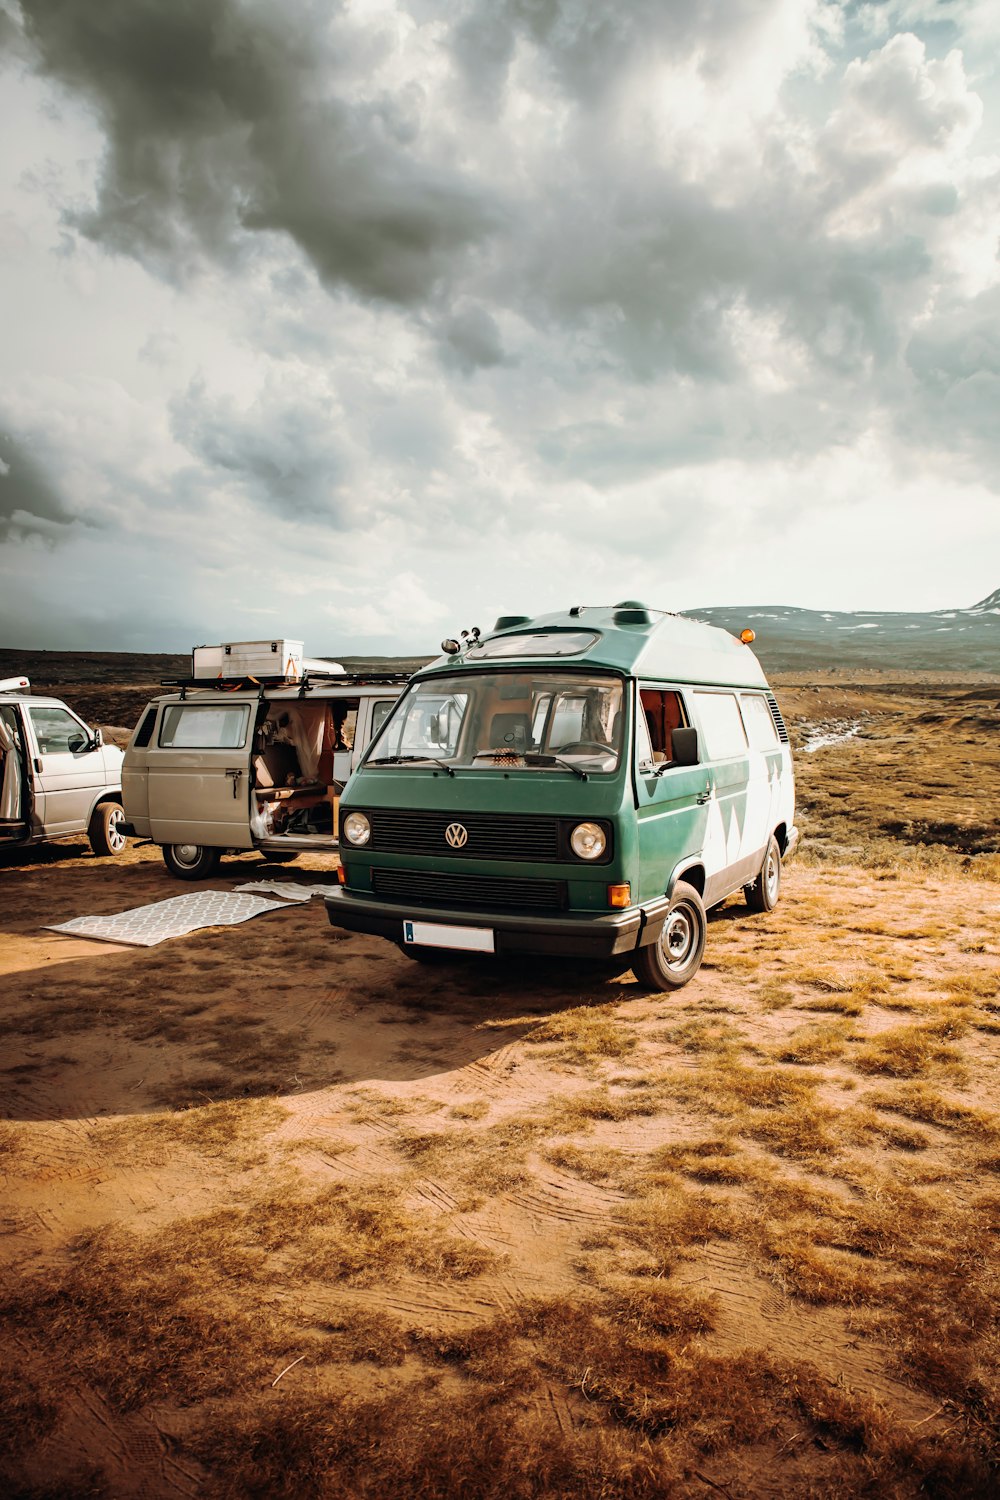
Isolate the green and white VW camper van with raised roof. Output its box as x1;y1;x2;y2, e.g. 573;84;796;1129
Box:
327;600;799;990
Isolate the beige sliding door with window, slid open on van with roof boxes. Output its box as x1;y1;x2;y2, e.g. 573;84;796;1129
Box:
145;693;258;849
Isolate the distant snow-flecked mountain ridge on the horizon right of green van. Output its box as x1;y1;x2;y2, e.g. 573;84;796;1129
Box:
684;588;1000;672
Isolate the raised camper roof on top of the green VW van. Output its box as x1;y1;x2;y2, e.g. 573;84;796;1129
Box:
417;600;768;687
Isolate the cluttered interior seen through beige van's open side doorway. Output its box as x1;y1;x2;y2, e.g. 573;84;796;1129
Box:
252;699;358;845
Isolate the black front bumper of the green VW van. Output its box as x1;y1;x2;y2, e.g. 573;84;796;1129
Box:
325;890;669;959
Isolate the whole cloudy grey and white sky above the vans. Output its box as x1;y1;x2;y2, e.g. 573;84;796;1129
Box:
0;0;1000;653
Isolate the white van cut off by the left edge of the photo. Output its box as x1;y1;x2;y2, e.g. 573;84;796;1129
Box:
0;677;127;855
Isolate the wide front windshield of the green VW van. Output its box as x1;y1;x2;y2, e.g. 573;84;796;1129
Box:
366;671;622;776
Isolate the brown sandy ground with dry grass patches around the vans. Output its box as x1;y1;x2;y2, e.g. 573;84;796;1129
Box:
0;684;1000;1500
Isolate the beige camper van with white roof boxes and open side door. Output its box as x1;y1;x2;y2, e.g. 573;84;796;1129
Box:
121;641;406;881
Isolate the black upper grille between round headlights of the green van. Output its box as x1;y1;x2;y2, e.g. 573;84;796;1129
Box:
367;807;559;864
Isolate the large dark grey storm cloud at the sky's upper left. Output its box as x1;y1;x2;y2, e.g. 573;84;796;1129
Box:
21;0;500;303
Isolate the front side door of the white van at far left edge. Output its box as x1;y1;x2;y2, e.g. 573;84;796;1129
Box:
25;704;106;834
